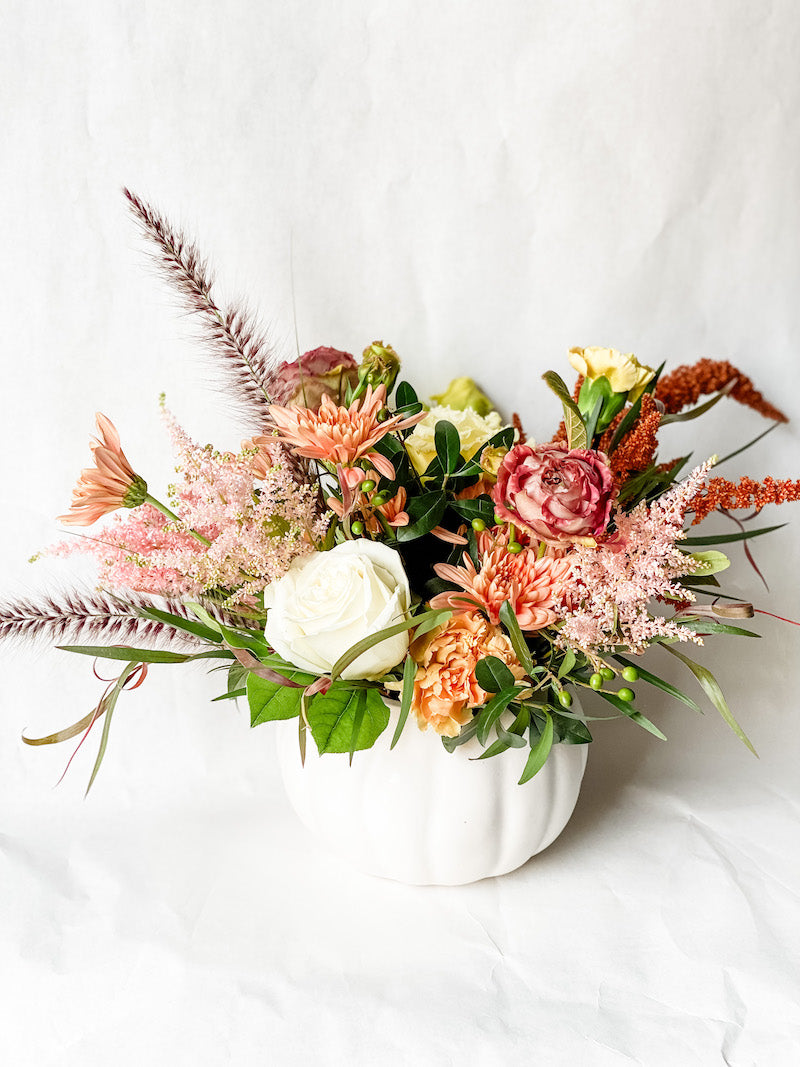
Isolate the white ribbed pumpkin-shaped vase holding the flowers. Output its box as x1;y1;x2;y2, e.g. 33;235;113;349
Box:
275;704;588;886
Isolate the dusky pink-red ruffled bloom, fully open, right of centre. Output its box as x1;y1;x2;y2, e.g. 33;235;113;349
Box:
492;445;615;544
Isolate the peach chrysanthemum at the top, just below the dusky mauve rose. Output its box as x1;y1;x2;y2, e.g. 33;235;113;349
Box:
270;385;426;478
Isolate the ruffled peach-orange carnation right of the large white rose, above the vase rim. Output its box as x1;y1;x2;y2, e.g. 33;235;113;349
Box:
411;614;525;737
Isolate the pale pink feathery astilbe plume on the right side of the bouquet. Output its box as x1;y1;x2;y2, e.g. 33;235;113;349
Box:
560;460;714;653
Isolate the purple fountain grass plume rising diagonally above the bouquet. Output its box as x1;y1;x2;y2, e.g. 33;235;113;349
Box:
123;189;278;431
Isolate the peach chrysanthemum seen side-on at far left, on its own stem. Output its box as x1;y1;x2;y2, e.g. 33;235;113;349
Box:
59;412;147;526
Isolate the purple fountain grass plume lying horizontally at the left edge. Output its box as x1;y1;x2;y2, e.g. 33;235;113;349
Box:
0;590;253;648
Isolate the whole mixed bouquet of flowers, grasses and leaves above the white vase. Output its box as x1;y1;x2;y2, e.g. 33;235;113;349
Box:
0;191;800;786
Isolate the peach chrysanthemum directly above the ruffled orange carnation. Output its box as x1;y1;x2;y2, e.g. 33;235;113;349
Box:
431;530;571;633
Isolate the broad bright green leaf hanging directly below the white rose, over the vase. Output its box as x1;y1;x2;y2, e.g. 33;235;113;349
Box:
308;682;389;755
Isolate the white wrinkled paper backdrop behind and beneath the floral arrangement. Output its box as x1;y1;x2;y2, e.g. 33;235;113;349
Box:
0;0;800;1067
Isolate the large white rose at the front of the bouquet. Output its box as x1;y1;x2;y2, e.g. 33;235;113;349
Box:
263;540;411;679
